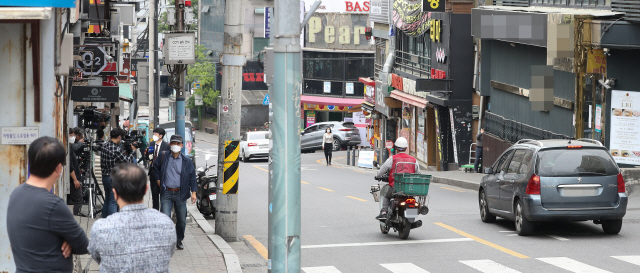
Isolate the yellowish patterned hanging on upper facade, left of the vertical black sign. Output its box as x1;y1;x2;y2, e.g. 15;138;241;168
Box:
393;0;430;37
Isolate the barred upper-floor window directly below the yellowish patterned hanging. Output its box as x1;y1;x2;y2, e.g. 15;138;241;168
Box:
395;32;431;77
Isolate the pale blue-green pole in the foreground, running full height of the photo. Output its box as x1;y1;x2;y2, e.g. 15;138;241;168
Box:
268;0;302;272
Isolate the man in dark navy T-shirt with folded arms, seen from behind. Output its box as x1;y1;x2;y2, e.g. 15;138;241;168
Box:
6;136;89;273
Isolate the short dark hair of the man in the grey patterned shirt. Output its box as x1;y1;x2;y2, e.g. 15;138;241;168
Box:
111;163;147;203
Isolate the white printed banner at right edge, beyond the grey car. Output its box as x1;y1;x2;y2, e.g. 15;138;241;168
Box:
609;90;640;165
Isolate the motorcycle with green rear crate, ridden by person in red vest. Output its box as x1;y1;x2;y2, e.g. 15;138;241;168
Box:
371;161;431;240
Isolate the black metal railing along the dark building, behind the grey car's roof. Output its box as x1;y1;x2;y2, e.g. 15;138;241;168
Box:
484;112;571;143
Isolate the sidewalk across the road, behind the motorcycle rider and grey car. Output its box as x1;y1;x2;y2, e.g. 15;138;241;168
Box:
332;152;484;190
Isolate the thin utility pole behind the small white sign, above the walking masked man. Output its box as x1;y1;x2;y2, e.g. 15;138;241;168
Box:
174;0;187;149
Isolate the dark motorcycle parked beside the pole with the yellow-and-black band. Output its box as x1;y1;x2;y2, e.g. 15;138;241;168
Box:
196;154;218;218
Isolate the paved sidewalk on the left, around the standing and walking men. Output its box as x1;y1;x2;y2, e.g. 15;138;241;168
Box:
74;178;228;273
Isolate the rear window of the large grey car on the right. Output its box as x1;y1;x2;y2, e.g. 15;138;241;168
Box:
536;148;618;177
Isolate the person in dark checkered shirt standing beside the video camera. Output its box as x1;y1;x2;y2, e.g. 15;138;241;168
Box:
100;128;136;218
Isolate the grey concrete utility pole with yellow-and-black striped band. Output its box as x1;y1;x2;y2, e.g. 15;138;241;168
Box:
215;0;246;242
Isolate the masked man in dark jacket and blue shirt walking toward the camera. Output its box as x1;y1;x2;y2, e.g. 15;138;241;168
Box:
153;135;198;249
